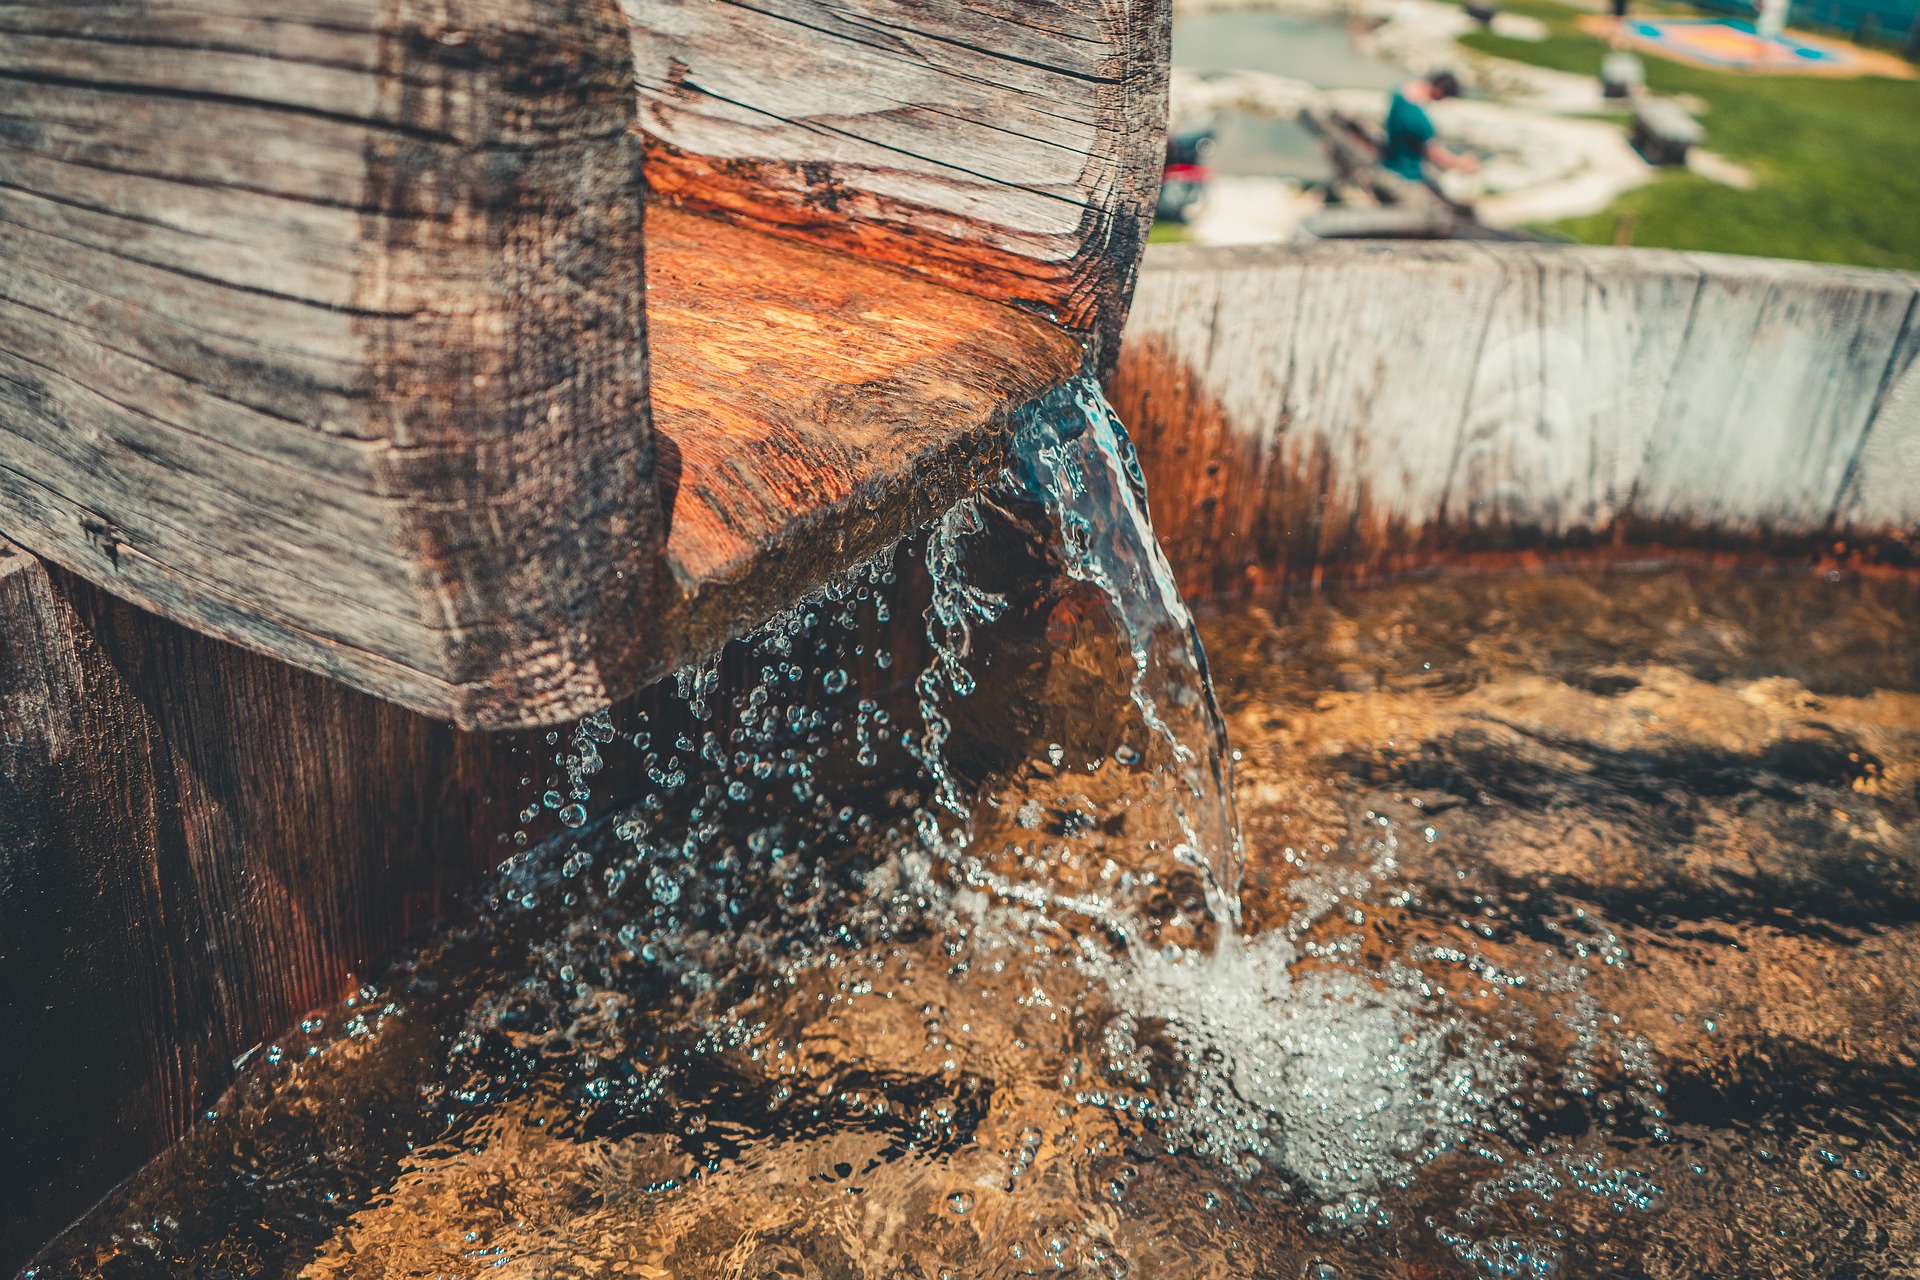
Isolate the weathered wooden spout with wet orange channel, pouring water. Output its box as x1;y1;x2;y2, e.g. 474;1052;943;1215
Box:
0;0;1167;727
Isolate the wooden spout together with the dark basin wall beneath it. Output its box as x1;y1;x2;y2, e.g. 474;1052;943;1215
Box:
0;0;1169;1265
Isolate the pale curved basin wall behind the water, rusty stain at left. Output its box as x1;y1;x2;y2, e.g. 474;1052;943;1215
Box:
1110;244;1920;595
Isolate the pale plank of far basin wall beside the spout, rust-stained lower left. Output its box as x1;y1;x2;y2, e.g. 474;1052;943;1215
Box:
1110;242;1501;593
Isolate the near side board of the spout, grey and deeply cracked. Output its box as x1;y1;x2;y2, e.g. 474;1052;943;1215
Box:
0;0;662;725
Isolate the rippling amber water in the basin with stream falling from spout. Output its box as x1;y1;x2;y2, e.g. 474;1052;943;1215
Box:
36;393;1920;1280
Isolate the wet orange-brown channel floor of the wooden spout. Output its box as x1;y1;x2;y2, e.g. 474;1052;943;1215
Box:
647;209;1083;679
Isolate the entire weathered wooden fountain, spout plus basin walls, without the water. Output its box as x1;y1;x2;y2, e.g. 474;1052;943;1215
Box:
0;0;1920;1267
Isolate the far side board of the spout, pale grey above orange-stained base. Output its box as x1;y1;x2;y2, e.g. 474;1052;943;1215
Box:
626;0;1171;355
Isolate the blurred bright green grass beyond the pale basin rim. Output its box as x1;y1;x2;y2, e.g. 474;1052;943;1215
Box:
1461;0;1920;269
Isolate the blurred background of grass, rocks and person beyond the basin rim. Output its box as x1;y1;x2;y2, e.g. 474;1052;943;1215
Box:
1154;0;1920;269
